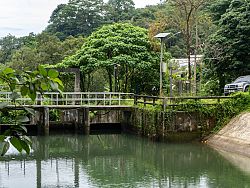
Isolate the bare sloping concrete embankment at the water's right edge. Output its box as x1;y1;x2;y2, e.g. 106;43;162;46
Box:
206;113;250;157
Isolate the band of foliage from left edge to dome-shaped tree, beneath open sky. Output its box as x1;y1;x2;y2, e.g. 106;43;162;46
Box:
0;33;84;70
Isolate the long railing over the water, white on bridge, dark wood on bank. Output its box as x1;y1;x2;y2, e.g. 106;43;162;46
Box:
0;92;233;110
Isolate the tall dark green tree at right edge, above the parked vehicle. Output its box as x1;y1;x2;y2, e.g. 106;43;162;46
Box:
205;0;250;91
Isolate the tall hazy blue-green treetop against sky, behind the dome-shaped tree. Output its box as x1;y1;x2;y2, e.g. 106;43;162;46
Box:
46;0;104;39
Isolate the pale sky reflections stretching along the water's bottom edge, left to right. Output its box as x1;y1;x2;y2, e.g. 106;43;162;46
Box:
0;158;211;188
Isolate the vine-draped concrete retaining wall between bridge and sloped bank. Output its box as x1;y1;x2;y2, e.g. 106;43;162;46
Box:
127;109;215;142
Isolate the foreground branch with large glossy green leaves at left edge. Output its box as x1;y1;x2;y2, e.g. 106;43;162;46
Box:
0;66;63;155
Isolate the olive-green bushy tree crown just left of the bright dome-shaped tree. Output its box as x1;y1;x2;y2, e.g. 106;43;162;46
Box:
8;32;84;70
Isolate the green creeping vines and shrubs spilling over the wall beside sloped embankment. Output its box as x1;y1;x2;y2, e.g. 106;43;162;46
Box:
135;93;250;137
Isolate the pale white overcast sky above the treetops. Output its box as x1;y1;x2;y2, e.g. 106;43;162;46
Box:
0;0;160;37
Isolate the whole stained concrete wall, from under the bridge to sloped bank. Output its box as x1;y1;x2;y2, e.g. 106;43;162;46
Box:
23;107;215;141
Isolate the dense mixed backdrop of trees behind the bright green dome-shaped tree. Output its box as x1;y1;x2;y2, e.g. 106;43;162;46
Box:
0;0;249;95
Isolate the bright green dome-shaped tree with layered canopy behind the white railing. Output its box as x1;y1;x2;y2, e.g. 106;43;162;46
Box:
58;23;159;92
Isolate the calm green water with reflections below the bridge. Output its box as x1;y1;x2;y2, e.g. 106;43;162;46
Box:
0;135;250;188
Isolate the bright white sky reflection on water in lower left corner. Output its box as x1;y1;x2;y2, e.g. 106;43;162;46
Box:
0;159;94;188
